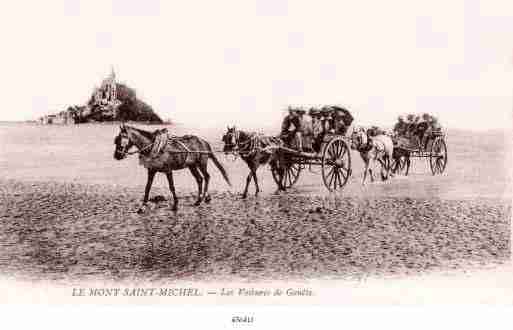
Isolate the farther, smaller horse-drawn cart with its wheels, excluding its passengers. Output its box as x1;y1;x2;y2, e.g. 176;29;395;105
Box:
392;130;447;175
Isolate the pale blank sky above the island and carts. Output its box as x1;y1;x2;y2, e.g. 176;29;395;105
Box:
0;0;513;129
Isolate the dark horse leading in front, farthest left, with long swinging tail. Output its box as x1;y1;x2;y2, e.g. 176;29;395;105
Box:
114;125;231;212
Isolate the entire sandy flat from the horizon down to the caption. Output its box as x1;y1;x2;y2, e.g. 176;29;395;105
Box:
0;124;512;302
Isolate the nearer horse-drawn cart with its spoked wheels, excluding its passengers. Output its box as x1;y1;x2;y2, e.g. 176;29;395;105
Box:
272;134;352;191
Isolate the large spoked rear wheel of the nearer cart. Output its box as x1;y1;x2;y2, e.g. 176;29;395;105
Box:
322;137;351;191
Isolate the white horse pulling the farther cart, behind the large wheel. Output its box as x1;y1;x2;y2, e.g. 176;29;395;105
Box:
351;128;394;185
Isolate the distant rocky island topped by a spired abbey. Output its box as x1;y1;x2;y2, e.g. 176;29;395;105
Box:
40;70;163;124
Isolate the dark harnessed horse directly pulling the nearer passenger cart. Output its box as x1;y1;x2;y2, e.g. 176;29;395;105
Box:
222;126;285;198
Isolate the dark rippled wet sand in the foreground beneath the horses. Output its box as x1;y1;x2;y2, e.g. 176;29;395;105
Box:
0;181;511;280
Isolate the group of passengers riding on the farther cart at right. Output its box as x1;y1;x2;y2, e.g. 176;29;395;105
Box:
393;113;442;149
